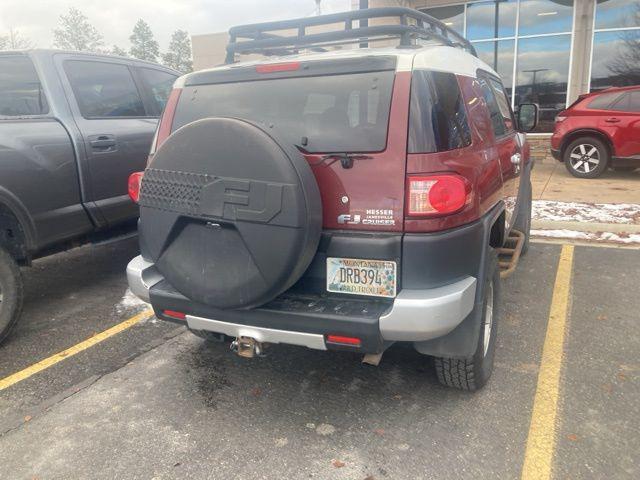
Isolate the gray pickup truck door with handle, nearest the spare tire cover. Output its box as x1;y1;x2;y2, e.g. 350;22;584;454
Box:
58;55;159;226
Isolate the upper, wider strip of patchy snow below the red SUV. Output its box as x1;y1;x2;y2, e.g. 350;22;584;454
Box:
531;200;640;224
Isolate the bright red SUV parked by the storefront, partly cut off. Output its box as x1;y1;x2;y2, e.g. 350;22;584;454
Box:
551;86;640;178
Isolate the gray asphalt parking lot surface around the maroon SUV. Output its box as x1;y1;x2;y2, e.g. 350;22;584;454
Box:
0;239;640;480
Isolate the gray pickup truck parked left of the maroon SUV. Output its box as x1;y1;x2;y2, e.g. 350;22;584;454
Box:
0;50;179;342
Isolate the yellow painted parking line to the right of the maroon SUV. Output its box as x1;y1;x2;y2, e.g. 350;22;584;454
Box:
521;245;573;480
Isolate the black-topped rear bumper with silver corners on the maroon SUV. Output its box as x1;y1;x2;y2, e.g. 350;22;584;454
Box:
127;256;477;352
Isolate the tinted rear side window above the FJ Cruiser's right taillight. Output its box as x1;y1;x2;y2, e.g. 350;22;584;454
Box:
409;70;471;153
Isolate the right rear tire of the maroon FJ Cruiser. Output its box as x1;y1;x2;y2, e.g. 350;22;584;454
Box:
434;252;501;392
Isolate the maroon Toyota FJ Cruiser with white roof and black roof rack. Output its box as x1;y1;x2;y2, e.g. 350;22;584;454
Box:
127;8;537;390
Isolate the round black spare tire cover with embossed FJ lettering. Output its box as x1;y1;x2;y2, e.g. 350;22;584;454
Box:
139;118;322;309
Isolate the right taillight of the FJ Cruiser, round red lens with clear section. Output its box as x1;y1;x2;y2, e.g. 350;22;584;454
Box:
407;174;470;216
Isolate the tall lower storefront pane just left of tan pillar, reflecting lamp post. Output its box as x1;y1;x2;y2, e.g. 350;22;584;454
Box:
515;35;571;132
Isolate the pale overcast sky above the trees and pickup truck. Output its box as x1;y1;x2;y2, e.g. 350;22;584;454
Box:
0;0;351;50
